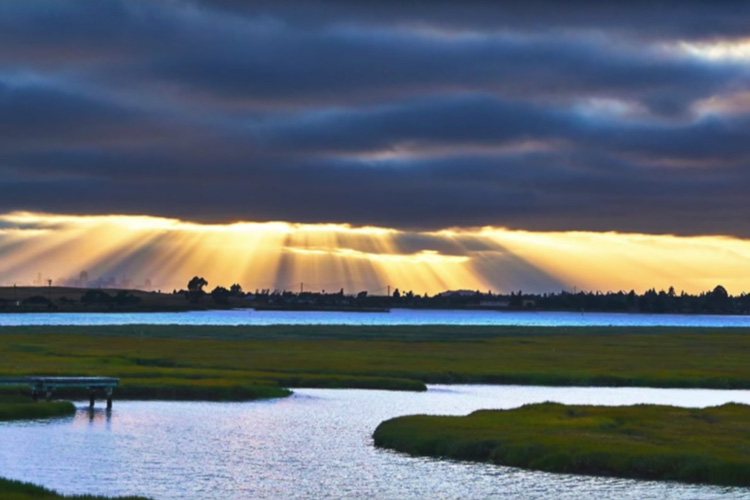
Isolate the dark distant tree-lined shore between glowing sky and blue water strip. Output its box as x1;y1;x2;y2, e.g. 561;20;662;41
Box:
0;286;750;317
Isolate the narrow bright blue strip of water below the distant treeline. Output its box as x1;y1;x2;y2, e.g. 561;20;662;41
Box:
0;309;750;327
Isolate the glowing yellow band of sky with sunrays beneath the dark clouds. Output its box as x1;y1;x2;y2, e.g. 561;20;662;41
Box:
0;212;750;295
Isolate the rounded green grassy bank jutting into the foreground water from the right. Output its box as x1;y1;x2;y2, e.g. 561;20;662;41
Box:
374;403;750;486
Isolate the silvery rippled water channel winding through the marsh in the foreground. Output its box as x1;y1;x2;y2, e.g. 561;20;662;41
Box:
0;386;750;500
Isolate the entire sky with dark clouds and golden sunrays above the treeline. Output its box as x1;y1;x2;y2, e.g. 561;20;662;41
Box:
0;0;750;293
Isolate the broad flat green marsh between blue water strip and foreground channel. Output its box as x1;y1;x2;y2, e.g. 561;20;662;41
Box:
0;325;750;399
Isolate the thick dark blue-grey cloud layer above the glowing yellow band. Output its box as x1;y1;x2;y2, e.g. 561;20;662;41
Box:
0;0;750;236
